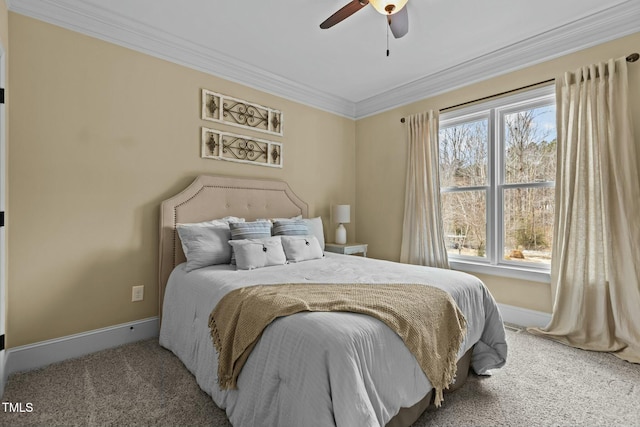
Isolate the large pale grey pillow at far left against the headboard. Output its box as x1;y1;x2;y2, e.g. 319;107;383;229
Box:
176;221;231;272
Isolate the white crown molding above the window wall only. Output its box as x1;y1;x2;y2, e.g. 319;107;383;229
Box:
356;0;640;119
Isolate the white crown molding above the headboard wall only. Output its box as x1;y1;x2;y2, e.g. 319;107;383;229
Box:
7;0;355;119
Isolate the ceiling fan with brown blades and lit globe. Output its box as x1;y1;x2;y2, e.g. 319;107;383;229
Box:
320;0;409;39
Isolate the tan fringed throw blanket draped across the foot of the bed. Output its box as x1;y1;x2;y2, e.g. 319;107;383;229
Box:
209;283;466;406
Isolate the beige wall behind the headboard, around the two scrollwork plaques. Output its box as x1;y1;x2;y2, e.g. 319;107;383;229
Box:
6;13;355;347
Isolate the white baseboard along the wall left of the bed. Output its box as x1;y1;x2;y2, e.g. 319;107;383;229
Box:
2;316;160;381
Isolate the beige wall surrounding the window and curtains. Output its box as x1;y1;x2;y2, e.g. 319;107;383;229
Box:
356;33;640;312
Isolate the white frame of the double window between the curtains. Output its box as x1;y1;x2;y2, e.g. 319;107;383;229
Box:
440;85;555;283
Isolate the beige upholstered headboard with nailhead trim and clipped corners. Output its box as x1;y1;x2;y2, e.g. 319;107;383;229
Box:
158;175;308;315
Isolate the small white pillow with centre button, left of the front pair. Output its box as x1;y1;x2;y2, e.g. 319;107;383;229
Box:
229;236;287;270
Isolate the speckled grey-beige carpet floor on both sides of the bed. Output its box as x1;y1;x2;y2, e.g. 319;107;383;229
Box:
0;329;640;427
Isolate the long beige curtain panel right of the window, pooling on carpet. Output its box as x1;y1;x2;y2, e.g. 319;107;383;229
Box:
531;58;640;363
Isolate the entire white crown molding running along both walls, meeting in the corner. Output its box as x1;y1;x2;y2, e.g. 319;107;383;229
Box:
6;0;640;120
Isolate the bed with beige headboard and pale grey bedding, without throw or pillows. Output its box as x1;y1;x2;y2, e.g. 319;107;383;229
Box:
158;176;507;427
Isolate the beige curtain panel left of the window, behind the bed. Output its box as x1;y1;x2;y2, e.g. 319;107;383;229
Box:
400;110;449;268
